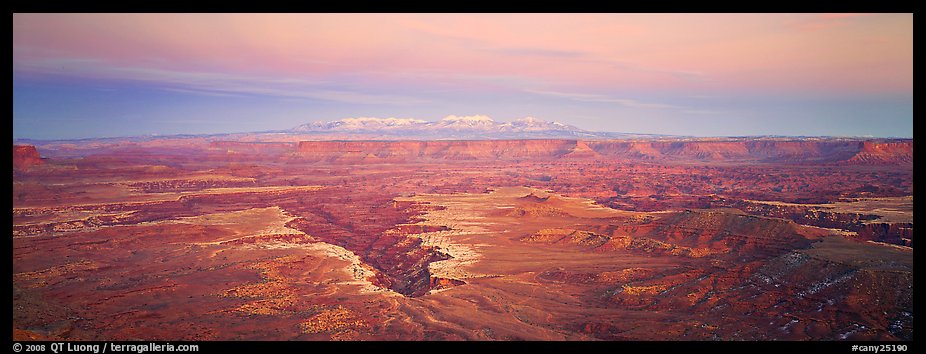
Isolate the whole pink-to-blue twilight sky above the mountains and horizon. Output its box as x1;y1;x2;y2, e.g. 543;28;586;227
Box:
13;13;913;139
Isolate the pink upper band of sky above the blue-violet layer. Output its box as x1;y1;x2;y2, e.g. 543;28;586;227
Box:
13;14;913;97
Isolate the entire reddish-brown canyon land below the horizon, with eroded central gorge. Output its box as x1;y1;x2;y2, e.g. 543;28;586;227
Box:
12;139;913;340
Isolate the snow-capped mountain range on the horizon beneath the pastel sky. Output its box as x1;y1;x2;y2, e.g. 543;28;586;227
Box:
292;115;597;139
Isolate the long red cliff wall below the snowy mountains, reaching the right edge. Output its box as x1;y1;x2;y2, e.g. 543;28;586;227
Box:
298;139;913;164
